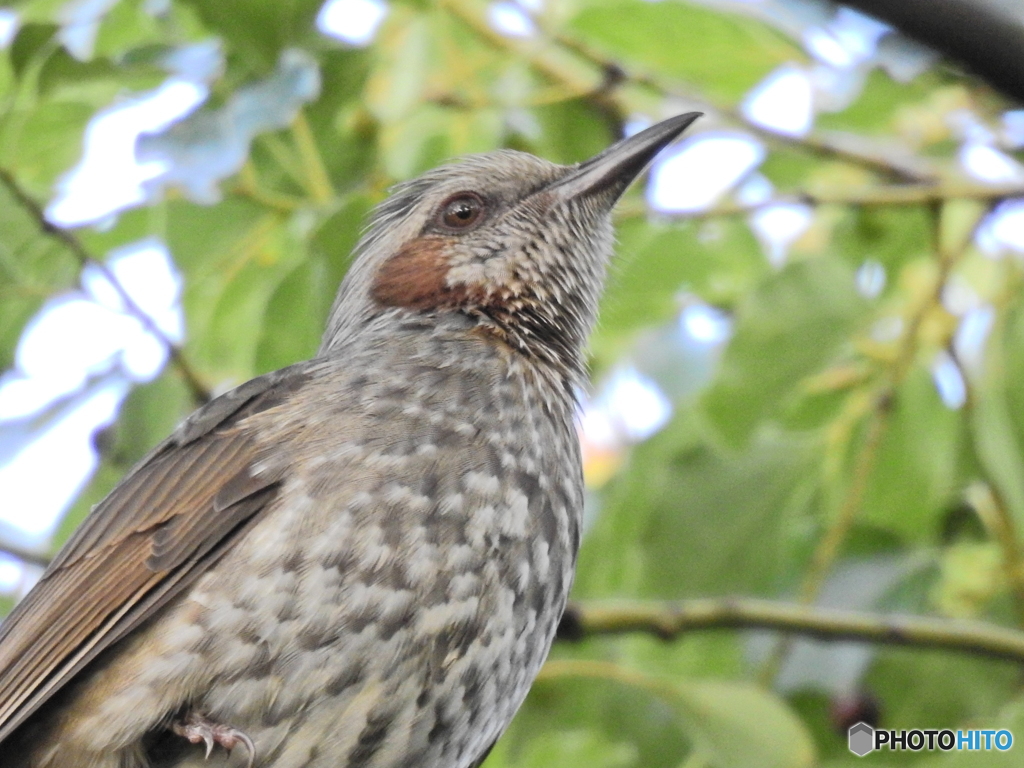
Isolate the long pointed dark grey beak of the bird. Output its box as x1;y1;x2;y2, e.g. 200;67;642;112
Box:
547;112;702;208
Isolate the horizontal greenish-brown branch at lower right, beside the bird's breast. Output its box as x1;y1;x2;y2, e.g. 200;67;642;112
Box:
556;598;1024;664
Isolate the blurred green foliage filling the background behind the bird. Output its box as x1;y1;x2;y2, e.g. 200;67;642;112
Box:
0;0;1024;768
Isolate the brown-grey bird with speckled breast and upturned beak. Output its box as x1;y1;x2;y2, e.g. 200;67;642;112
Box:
0;113;699;768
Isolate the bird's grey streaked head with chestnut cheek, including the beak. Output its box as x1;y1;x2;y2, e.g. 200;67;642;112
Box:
322;113;699;372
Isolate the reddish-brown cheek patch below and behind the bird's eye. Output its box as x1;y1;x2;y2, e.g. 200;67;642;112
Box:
371;237;485;310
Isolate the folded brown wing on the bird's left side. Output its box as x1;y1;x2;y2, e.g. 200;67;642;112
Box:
0;364;309;741
